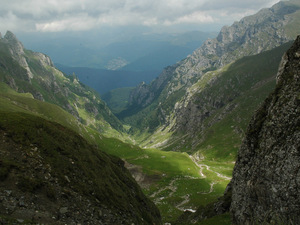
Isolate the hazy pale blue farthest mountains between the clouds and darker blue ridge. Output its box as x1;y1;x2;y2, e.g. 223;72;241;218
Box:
21;31;216;71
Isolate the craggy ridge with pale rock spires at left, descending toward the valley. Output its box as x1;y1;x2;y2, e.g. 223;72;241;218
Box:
0;31;123;136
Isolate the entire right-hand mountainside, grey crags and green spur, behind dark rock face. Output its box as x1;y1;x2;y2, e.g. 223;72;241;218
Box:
117;1;300;155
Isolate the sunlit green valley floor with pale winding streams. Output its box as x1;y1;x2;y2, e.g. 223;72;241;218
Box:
99;142;234;223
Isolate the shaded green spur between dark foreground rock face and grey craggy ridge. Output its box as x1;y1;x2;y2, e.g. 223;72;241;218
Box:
159;42;291;155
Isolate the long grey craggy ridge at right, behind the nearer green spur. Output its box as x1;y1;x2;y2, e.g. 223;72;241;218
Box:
118;0;300;152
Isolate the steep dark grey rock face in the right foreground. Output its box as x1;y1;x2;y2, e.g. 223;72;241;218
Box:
231;36;300;224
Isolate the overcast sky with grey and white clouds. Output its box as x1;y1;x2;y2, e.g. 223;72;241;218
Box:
0;0;278;32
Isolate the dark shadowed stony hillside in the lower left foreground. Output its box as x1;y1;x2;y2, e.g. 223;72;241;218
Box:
0;109;160;224
